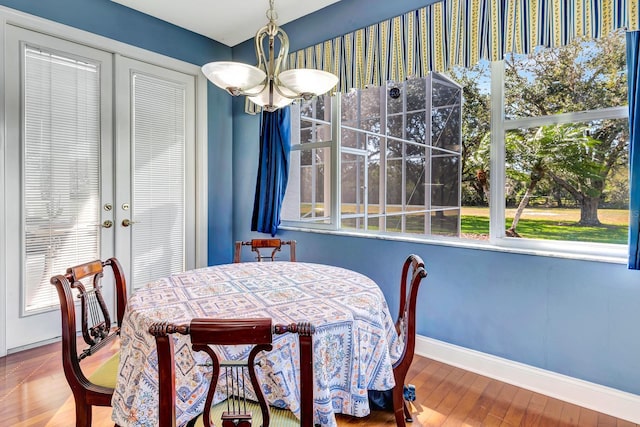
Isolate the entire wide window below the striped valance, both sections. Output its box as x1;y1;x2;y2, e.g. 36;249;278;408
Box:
283;32;629;260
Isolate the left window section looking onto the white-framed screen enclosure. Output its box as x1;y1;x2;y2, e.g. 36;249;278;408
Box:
283;74;462;236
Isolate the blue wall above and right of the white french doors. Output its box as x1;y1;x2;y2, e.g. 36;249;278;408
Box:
0;0;233;264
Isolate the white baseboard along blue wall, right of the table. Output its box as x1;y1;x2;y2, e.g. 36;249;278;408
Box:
416;336;640;424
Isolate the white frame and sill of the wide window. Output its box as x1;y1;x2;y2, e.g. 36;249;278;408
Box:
283;57;629;264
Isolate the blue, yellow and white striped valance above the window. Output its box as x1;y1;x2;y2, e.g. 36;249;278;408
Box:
287;0;640;92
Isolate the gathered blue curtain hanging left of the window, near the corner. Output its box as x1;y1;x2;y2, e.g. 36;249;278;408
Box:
251;107;291;236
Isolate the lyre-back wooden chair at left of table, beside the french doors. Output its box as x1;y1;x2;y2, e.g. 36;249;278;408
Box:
51;258;127;427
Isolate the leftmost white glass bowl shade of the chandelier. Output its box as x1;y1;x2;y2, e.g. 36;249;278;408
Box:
202;61;267;96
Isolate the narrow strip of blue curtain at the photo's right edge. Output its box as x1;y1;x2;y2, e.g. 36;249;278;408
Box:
627;31;640;270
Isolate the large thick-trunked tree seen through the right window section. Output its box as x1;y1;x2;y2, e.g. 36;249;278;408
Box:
505;33;628;225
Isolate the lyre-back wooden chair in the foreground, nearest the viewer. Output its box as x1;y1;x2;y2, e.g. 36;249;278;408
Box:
149;318;314;427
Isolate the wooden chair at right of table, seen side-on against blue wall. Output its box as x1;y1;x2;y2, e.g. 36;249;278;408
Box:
392;255;427;427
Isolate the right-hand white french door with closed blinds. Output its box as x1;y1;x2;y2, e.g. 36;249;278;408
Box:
114;57;196;289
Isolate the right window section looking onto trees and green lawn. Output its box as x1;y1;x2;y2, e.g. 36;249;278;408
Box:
497;32;629;249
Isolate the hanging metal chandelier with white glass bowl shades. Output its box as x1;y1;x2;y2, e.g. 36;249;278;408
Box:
202;0;338;111
